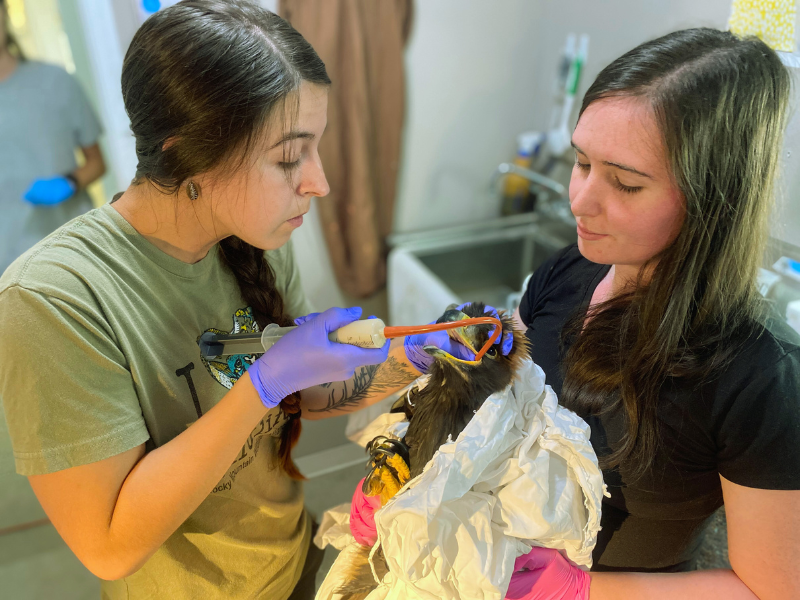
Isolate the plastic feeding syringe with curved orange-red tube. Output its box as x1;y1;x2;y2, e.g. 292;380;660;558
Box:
198;317;503;361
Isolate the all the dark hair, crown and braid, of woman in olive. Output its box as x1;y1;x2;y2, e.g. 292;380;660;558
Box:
122;0;330;478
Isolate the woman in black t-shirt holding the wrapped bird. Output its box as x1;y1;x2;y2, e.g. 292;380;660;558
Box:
517;29;800;600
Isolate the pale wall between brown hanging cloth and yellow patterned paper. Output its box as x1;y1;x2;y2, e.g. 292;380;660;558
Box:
395;0;731;231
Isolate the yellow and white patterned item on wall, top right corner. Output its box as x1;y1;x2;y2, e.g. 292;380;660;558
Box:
728;0;797;52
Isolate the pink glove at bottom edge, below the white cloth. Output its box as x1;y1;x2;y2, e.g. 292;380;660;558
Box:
506;547;591;600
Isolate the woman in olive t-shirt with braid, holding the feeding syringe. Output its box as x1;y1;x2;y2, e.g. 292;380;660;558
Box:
0;0;500;600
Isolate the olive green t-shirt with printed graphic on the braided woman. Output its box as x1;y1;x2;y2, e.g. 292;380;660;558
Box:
0;205;310;600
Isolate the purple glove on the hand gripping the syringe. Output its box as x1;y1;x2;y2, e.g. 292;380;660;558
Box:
247;307;389;408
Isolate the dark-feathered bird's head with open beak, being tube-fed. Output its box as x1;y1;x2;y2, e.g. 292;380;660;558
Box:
425;302;528;396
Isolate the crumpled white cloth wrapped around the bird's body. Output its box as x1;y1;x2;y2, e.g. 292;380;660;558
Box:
315;361;605;600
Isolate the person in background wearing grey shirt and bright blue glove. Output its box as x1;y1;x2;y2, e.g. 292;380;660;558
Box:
0;0;106;273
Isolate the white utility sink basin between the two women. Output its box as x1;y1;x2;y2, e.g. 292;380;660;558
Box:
388;213;577;325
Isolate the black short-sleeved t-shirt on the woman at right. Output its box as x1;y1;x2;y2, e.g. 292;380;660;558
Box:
520;245;800;571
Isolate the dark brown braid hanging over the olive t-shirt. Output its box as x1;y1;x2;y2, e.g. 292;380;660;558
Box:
219;236;305;479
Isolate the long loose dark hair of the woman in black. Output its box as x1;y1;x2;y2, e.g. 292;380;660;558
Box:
562;29;790;479
